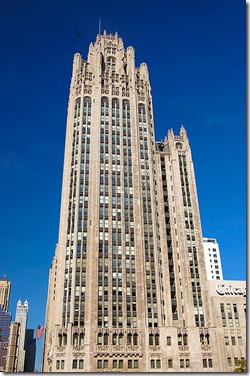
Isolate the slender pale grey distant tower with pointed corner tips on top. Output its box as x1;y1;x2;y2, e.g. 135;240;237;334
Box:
15;300;28;372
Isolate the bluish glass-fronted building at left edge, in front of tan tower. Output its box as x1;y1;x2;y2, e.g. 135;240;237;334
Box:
0;306;11;371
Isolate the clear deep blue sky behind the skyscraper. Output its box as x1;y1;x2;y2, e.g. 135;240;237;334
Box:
0;0;246;369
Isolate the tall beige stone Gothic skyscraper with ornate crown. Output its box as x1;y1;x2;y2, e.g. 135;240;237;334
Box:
43;33;244;372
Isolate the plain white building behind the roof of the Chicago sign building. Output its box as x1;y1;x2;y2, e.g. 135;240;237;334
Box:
203;238;223;280
